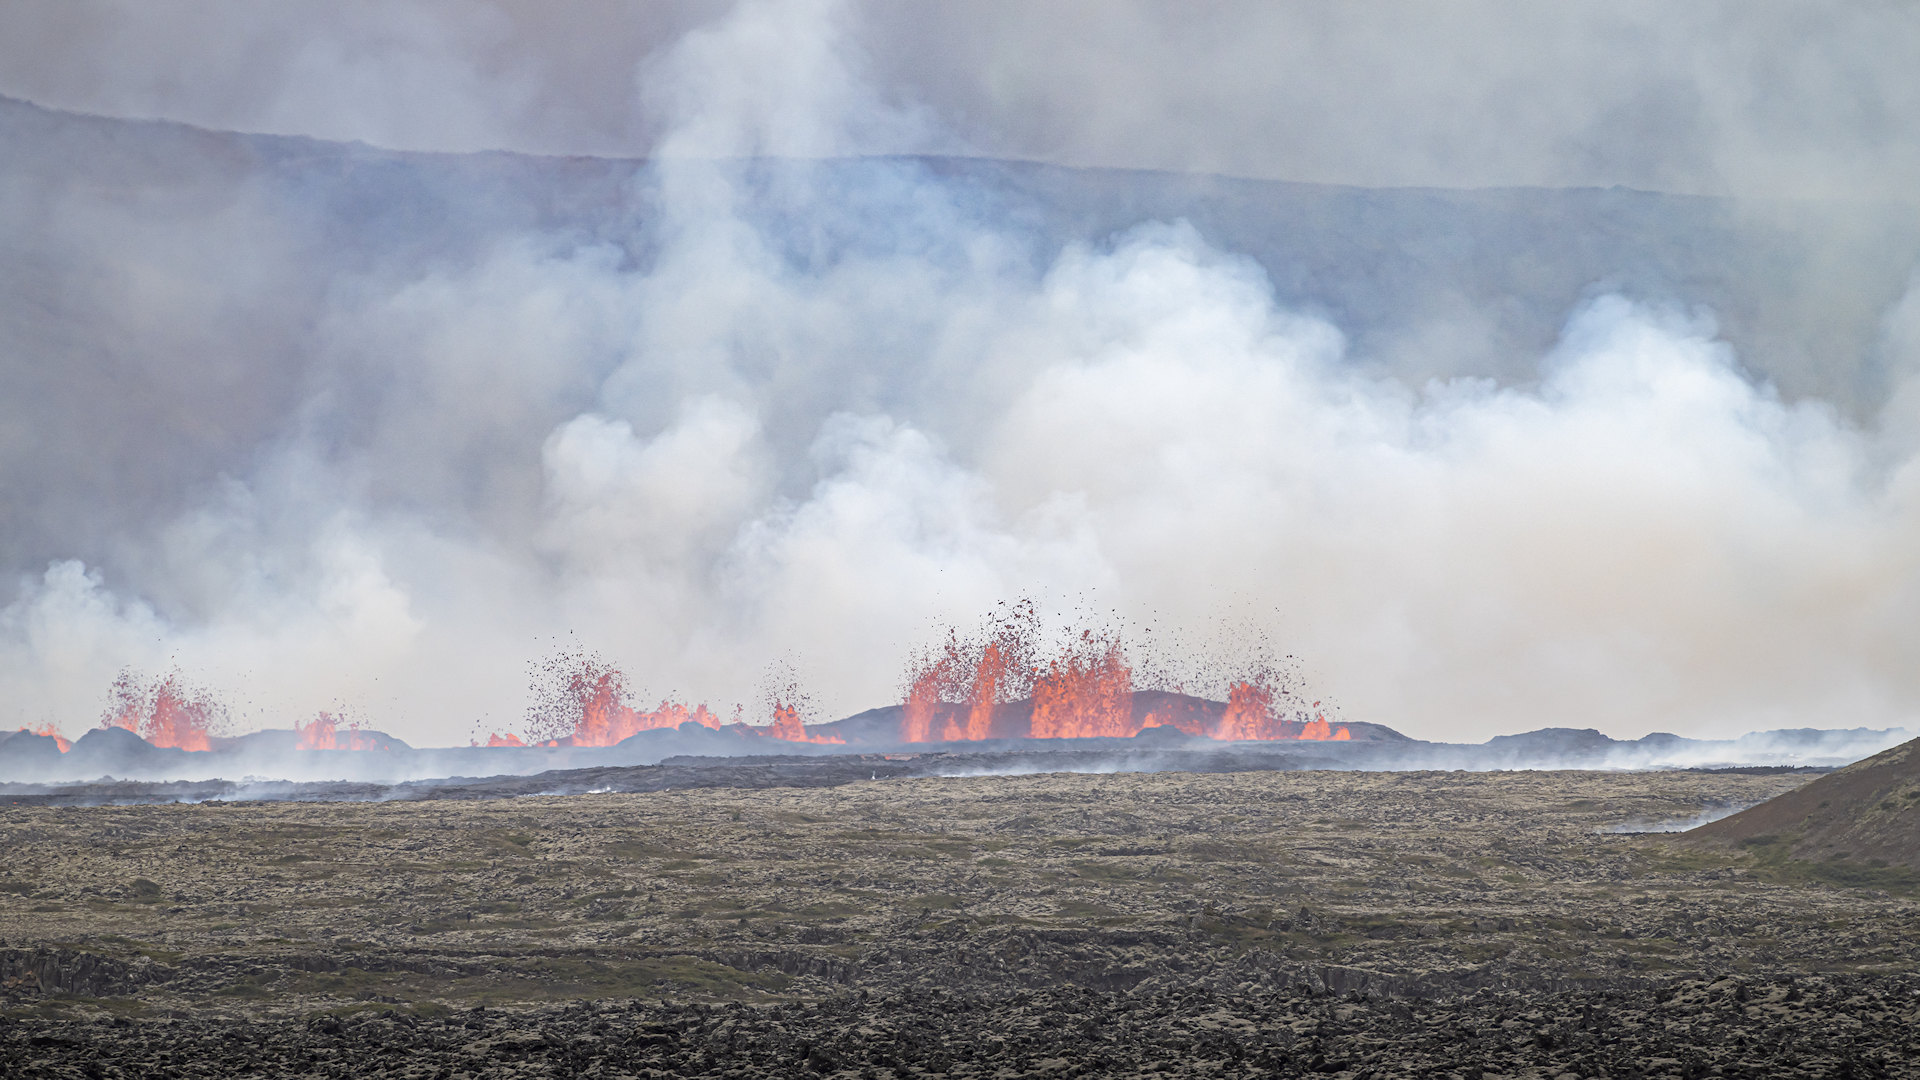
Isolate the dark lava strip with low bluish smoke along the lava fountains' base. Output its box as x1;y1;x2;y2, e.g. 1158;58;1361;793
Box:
0;714;1920;780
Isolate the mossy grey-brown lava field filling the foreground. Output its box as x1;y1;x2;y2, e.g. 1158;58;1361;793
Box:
0;771;1920;1078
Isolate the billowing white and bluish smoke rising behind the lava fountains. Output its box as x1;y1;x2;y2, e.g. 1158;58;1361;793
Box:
0;4;1920;744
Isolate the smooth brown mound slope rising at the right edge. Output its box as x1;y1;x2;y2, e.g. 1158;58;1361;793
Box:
1684;738;1920;869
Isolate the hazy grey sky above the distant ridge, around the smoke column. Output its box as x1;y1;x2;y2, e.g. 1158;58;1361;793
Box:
11;0;1920;198
